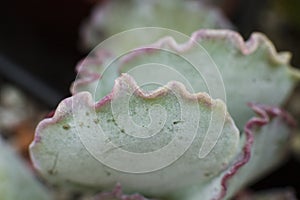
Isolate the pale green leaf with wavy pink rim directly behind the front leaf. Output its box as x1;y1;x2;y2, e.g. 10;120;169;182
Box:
71;30;300;129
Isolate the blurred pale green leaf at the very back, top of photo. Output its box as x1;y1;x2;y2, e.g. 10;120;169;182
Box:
82;0;232;49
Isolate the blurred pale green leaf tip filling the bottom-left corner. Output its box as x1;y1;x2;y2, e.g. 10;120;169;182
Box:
0;138;51;200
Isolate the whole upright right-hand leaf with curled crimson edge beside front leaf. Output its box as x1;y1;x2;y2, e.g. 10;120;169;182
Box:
168;104;295;200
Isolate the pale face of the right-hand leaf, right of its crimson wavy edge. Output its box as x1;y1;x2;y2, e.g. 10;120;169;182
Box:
221;104;295;199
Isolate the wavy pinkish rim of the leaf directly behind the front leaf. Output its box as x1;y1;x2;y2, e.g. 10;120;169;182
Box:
70;29;300;95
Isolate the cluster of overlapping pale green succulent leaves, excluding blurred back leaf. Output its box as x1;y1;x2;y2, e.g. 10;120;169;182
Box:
30;27;300;200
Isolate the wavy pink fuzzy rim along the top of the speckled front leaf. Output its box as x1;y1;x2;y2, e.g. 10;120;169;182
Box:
30;73;223;148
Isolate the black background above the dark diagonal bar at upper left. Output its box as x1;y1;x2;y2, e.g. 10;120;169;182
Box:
0;0;93;106
